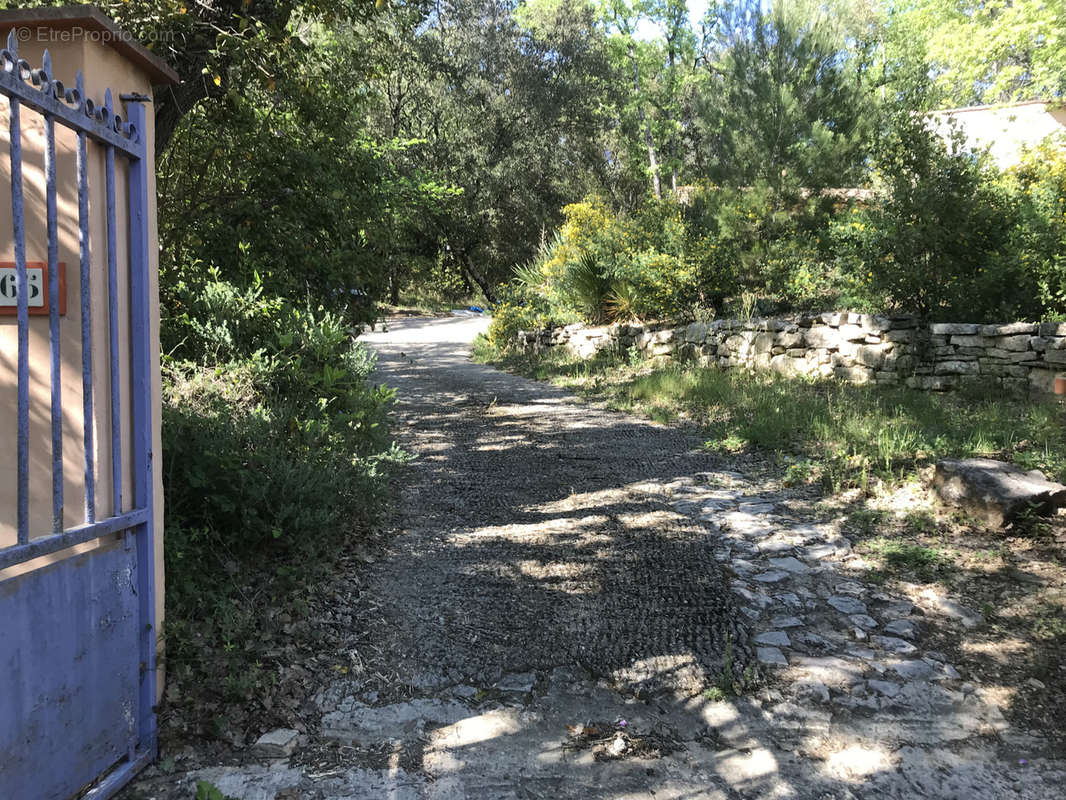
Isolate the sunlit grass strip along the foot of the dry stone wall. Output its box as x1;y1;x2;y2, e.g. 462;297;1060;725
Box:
475;334;1066;492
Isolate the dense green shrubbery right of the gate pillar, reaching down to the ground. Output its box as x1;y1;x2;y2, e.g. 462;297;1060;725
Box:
162;281;402;698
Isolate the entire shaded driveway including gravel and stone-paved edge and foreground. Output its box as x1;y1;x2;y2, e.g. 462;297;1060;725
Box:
128;318;1066;800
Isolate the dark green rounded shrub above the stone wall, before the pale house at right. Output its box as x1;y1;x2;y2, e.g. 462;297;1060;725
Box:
831;113;1038;321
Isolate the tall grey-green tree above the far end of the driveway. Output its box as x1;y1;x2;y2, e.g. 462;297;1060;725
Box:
356;0;612;299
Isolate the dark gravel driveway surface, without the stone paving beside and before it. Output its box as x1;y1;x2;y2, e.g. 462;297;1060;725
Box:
365;318;750;693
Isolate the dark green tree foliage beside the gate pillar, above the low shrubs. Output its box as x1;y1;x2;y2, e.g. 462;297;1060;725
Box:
159;36;439;322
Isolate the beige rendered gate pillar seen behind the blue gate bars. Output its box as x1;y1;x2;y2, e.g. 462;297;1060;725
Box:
0;14;173;678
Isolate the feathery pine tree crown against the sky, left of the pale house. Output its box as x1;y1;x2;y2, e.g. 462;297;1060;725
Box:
697;0;871;189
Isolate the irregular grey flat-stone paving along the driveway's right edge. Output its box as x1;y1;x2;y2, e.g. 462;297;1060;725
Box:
664;471;1008;745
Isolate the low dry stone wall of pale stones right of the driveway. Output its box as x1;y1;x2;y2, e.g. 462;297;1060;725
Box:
518;313;1066;391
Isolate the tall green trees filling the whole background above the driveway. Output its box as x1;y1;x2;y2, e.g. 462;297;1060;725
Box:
10;0;1066;318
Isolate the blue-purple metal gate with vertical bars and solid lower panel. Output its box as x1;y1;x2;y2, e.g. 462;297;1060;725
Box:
0;32;156;800
